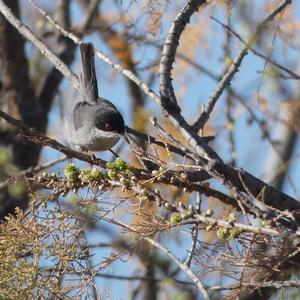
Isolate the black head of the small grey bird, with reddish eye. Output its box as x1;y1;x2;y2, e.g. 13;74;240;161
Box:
95;109;125;134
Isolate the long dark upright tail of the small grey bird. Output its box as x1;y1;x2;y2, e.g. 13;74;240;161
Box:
80;43;98;104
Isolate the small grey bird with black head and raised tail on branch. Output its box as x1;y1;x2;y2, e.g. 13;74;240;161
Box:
64;43;128;151
